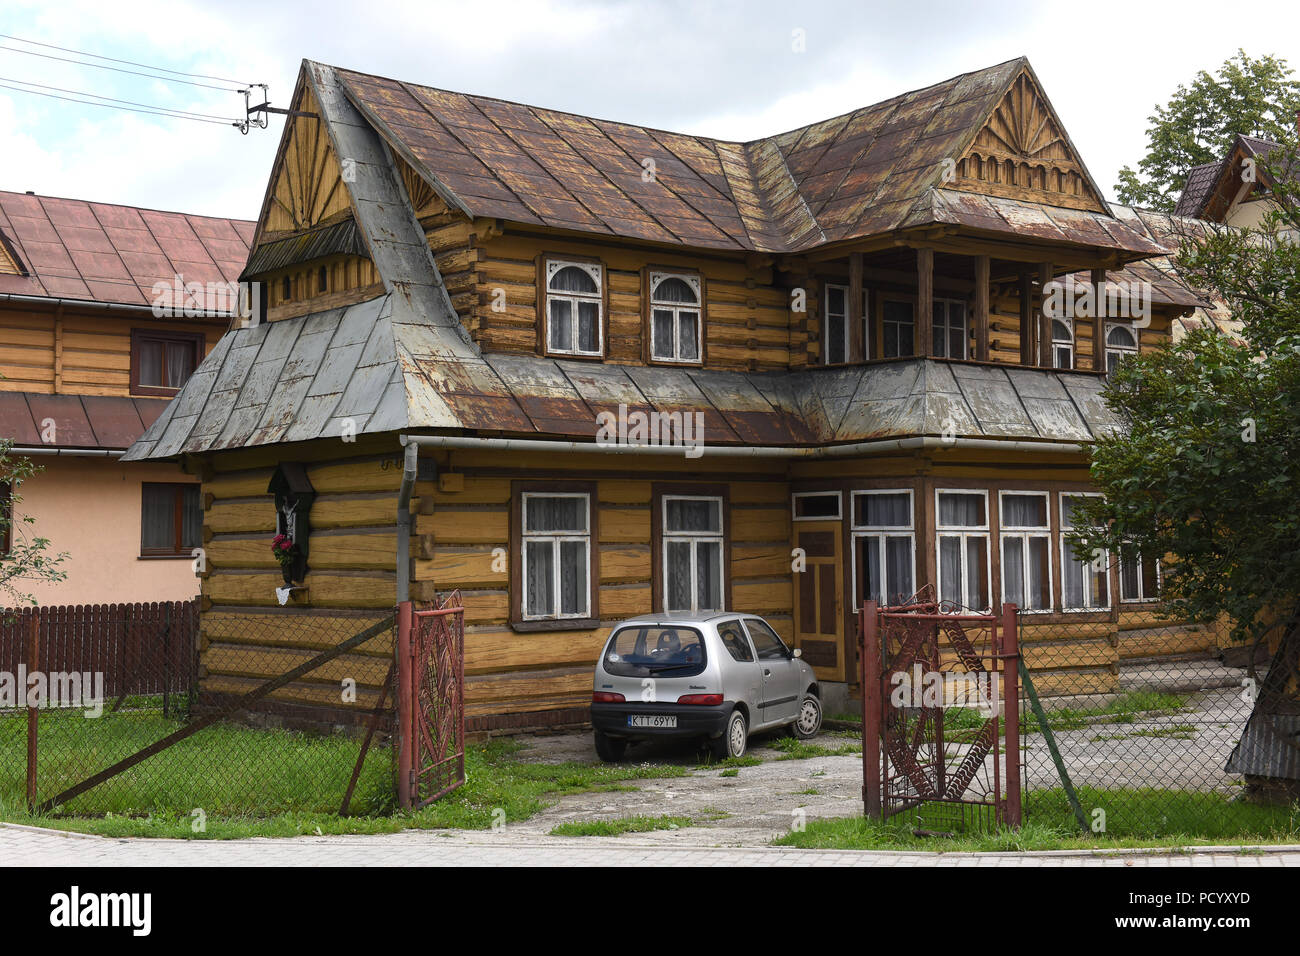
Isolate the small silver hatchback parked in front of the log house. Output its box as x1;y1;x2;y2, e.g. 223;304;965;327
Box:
592;611;822;761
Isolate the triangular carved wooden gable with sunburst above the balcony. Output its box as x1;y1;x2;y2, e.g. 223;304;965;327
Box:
949;70;1110;215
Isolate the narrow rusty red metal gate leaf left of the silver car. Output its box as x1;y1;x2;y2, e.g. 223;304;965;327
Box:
395;591;465;809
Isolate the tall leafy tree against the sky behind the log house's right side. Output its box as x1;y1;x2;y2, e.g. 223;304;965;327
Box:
1115;49;1300;212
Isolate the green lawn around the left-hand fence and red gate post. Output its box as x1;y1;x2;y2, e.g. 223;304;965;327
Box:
0;714;688;839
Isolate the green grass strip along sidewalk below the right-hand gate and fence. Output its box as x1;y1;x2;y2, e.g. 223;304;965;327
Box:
774;787;1300;852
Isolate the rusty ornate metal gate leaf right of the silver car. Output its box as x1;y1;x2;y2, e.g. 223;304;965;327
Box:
859;592;1021;831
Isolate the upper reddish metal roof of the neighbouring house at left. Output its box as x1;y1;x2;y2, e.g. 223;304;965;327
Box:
0;191;256;308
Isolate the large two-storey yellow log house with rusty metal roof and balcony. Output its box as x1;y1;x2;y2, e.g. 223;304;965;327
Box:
127;60;1222;728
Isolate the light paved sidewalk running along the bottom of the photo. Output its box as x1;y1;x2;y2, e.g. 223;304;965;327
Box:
0;823;1300;868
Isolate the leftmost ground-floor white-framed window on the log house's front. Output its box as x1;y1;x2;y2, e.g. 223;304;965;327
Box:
520;492;592;620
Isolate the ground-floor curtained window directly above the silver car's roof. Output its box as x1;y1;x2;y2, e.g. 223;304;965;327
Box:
662;494;724;613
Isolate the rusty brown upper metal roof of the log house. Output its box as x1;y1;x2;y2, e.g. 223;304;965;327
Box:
338;57;1156;254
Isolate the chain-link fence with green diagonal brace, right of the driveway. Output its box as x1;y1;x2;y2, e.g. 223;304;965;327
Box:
1019;610;1296;838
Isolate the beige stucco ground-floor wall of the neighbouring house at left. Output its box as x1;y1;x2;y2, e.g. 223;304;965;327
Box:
0;457;199;605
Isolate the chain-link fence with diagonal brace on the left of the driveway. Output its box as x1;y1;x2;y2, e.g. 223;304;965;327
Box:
0;605;394;822
